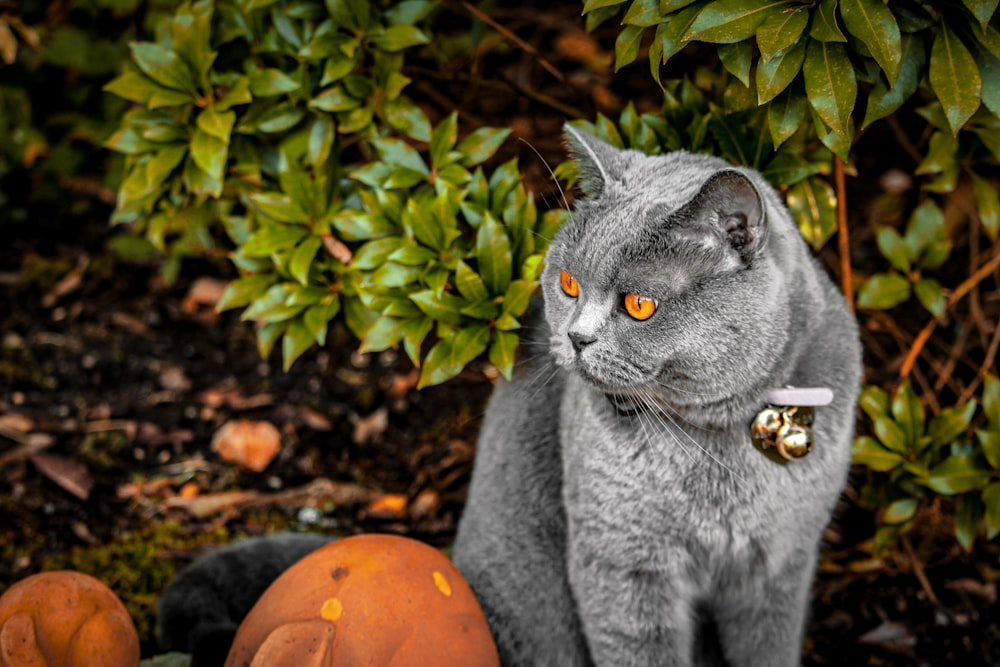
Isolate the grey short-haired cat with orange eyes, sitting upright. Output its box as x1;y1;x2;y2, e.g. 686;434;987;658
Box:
453;126;861;667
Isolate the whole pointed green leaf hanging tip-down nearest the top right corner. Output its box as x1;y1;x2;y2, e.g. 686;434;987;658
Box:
929;22;982;135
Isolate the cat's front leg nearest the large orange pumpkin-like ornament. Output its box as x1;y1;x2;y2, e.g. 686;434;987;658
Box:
570;559;694;667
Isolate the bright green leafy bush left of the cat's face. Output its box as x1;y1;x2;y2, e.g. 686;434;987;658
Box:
107;0;562;386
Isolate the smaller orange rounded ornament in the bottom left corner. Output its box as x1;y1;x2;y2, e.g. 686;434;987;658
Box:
0;570;139;667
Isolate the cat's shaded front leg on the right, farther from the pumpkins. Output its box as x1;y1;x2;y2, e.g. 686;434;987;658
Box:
715;549;816;667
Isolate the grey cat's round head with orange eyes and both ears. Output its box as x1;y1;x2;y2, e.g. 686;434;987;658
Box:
542;126;792;406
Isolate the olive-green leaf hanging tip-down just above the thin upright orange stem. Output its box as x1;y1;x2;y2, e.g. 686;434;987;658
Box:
802;40;858;136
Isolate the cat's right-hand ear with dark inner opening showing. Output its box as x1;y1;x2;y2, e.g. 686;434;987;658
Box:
685;169;767;264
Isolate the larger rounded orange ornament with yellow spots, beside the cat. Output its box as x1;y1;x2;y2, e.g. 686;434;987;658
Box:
226;535;500;667
